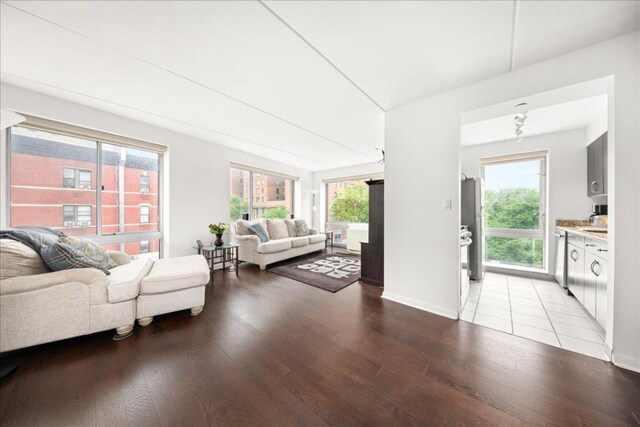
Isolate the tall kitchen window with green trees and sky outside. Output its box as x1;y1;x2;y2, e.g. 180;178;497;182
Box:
482;153;546;269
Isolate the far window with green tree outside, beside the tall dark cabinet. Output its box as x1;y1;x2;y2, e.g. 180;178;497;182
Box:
325;175;382;246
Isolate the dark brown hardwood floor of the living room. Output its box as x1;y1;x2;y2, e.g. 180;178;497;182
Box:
0;251;640;427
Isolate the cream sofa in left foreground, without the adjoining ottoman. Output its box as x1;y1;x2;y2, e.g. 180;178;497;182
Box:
0;239;153;352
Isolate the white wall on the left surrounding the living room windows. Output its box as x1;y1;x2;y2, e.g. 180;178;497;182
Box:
0;84;311;257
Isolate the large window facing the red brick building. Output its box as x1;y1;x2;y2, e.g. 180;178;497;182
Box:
8;119;164;256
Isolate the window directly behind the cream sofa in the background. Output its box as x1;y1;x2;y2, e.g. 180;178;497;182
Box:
229;167;294;221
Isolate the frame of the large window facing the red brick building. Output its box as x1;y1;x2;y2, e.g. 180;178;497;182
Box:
2;117;167;258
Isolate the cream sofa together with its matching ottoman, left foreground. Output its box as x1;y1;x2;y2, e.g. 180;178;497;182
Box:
0;239;209;352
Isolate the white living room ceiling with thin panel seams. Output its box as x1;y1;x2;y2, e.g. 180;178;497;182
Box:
0;1;640;170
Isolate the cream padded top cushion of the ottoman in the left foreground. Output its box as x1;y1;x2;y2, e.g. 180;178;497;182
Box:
140;255;210;295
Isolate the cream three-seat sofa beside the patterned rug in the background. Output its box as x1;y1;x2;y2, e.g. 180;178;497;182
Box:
231;219;326;270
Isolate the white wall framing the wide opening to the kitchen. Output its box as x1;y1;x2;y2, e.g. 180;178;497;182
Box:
383;32;640;371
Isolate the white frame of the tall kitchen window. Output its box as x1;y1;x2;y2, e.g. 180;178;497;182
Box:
480;150;549;272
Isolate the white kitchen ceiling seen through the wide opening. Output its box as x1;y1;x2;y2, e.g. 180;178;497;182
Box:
460;95;607;147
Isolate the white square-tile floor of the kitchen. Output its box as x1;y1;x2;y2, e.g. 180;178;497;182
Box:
460;273;607;360
